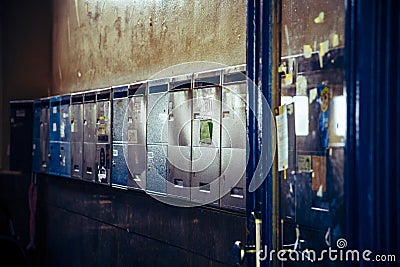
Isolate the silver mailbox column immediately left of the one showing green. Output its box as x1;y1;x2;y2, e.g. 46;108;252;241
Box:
167;75;192;200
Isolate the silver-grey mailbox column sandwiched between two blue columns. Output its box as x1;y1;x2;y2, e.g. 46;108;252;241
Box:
123;83;147;190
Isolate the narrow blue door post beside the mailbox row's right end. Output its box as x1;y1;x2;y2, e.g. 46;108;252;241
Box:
246;0;273;266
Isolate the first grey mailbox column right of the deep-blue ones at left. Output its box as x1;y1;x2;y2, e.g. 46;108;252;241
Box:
70;94;83;179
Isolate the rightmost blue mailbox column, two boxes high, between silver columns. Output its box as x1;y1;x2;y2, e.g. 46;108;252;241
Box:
146;79;169;193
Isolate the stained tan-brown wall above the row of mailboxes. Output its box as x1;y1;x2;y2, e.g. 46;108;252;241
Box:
52;0;246;94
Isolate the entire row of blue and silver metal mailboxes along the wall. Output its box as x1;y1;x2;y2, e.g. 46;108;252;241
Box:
32;66;247;209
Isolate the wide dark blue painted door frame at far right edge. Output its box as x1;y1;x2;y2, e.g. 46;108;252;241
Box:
344;0;400;266
